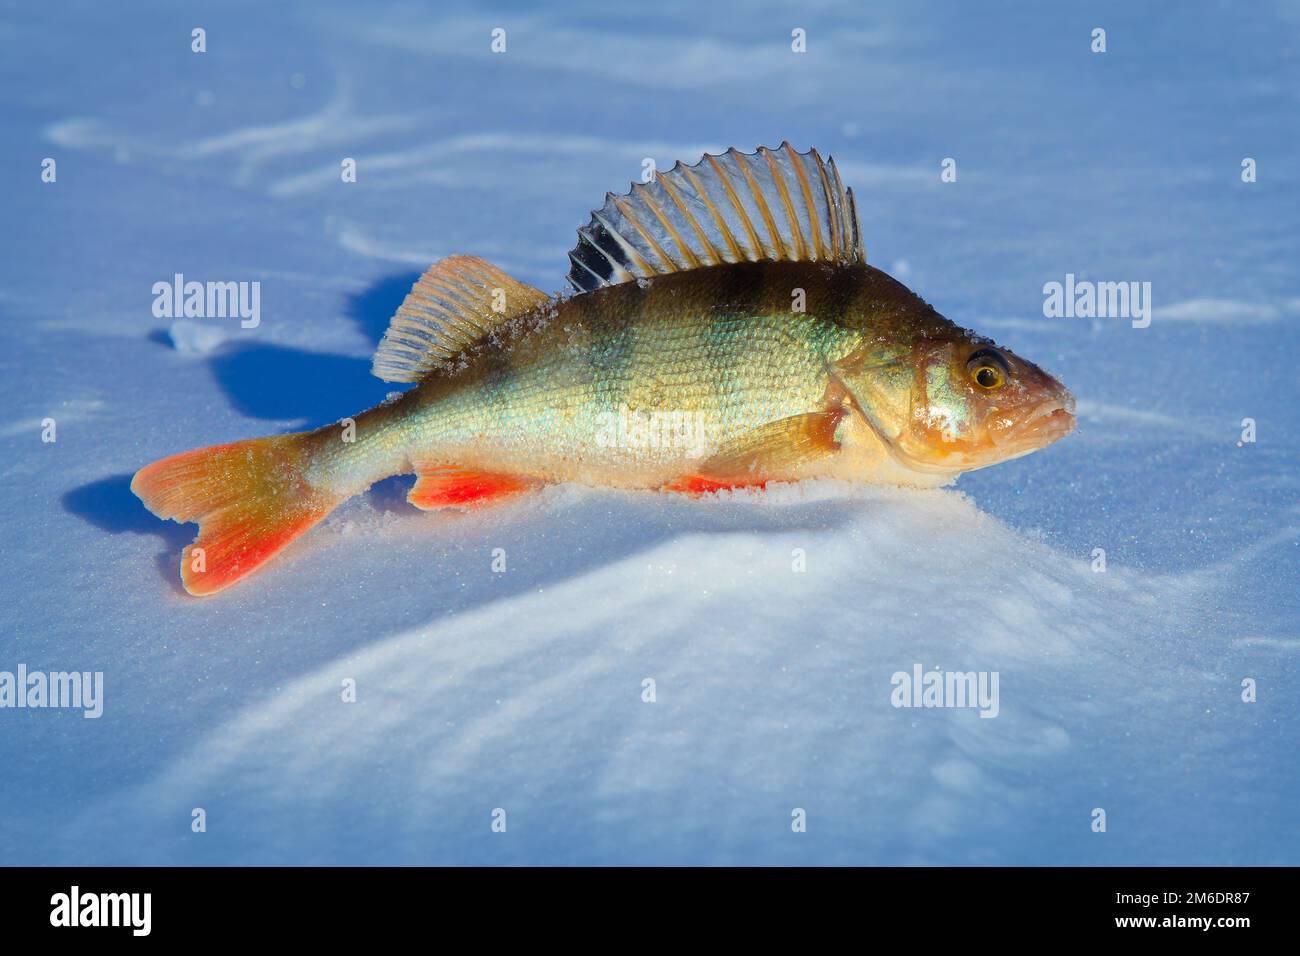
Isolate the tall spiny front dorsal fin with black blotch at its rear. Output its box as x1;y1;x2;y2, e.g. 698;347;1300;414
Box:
568;143;866;293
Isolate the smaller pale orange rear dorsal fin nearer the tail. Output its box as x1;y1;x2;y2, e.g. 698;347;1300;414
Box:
371;256;549;381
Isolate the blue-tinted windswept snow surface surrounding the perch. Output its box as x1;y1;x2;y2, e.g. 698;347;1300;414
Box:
0;0;1300;864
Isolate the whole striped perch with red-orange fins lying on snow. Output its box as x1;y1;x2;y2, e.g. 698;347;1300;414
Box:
131;142;1075;596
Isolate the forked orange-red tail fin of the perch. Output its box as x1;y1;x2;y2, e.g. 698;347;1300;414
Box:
131;433;343;594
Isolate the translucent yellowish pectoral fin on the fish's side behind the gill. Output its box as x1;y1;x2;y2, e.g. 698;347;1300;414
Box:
664;408;844;494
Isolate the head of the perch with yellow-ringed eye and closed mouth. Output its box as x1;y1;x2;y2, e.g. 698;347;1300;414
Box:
848;335;1075;475
